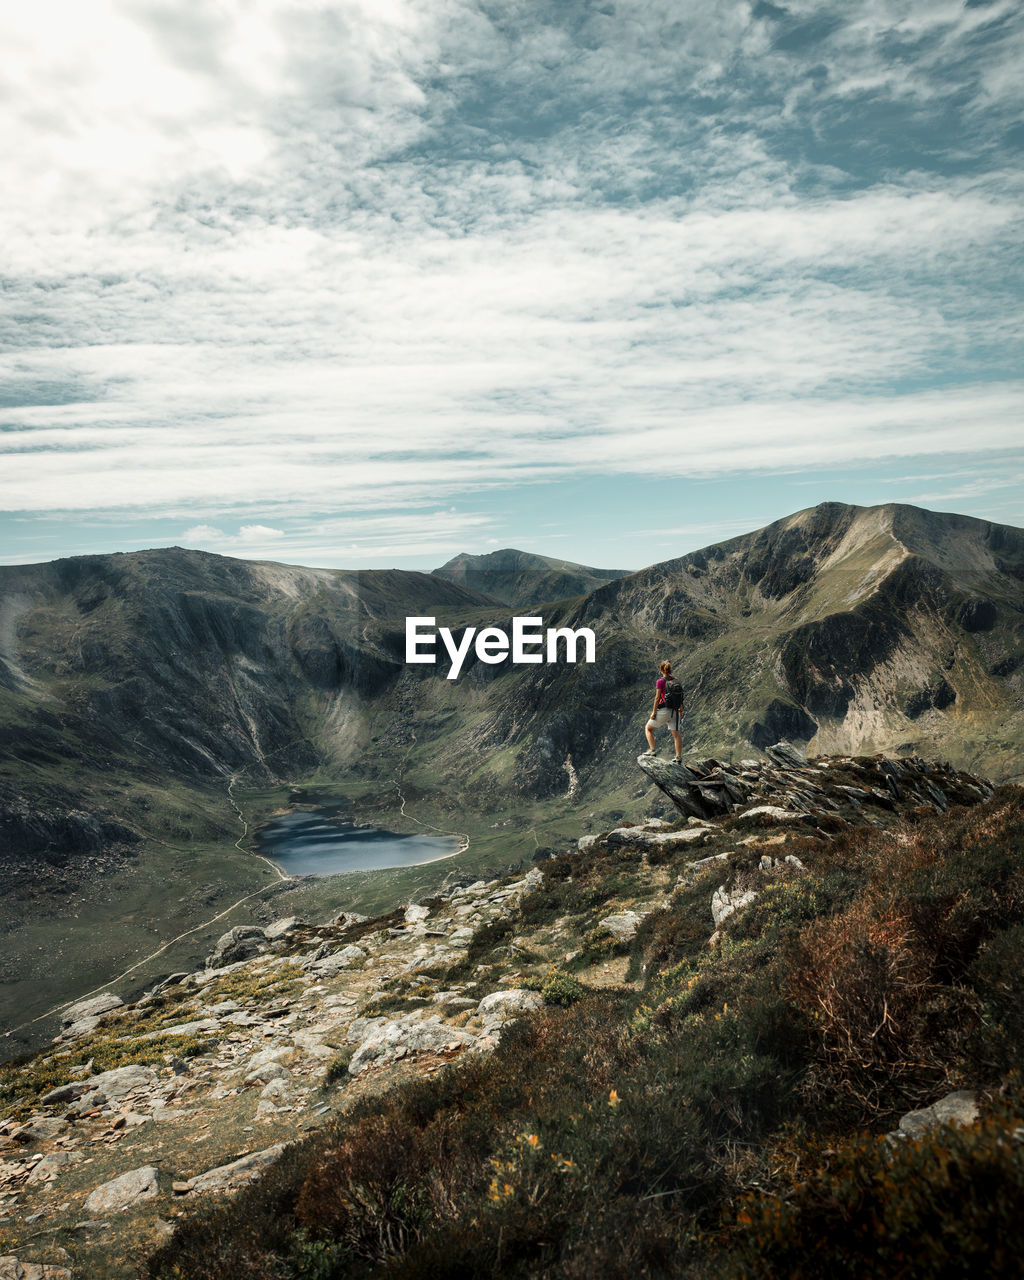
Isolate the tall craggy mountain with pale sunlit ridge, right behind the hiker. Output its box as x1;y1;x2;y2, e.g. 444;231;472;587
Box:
494;503;1024;786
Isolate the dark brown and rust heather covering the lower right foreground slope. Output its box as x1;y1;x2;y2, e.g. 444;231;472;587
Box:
148;788;1024;1280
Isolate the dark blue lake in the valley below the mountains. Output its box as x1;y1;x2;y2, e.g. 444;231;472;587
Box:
256;813;458;876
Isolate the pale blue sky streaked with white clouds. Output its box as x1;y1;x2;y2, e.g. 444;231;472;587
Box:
0;0;1024;568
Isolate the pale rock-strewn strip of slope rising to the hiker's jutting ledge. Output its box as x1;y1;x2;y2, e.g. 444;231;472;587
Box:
0;744;992;1277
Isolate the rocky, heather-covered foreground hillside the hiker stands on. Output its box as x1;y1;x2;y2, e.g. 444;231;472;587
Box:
0;744;1024;1280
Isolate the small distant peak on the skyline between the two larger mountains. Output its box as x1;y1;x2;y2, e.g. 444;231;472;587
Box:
433;547;628;609
